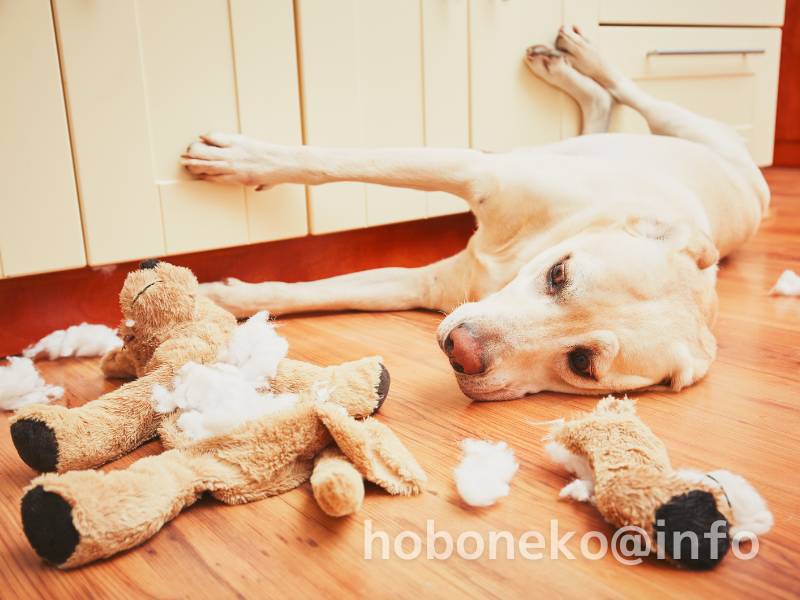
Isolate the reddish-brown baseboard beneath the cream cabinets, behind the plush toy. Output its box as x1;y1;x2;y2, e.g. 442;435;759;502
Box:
0;214;475;356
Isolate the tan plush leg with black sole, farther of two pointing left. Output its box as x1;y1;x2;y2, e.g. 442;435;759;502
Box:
11;367;173;472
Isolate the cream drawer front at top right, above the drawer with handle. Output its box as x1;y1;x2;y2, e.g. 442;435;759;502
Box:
599;0;784;26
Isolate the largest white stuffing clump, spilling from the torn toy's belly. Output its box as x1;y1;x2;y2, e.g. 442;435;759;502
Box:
153;312;297;440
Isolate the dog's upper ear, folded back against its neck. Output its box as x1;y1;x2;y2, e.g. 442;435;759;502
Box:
625;216;719;269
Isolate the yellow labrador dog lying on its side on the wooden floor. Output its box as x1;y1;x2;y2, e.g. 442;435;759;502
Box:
183;27;769;400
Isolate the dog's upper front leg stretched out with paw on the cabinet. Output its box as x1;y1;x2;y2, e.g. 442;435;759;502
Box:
181;133;497;212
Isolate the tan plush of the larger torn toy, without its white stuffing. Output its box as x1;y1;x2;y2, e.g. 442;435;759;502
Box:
15;263;425;568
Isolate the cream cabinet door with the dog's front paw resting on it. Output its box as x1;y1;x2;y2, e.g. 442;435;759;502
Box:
54;0;306;264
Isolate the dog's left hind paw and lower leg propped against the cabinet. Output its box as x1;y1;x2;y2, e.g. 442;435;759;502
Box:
525;45;614;135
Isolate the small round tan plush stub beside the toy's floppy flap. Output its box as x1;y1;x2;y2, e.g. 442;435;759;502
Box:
311;446;364;517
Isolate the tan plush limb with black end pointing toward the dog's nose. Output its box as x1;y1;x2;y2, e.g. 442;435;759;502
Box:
271;356;390;417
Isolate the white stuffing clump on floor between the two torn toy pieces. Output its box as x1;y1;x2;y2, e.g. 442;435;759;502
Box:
453;440;519;506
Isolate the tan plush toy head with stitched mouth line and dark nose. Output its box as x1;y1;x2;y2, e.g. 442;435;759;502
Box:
119;259;199;331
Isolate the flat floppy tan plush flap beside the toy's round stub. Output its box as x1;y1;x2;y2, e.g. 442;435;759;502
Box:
316;402;427;496
